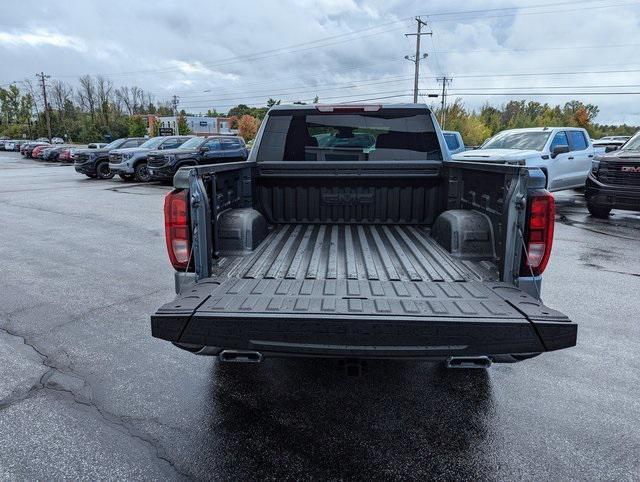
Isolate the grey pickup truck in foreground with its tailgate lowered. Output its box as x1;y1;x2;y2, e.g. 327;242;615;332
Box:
151;104;577;368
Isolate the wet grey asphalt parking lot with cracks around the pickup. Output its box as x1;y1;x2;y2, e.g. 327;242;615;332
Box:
0;152;640;480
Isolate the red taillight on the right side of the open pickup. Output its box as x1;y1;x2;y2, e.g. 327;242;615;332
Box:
523;191;556;276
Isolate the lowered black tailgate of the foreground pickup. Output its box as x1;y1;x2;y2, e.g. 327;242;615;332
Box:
151;278;577;358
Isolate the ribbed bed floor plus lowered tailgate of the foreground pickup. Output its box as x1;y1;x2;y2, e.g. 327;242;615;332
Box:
152;224;575;358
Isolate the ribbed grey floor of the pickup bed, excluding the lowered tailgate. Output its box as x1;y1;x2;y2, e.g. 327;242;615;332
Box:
236;224;479;282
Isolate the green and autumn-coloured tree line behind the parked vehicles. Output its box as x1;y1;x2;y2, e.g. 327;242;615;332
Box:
0;75;638;146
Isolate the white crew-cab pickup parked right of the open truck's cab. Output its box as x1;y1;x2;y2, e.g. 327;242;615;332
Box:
453;127;594;191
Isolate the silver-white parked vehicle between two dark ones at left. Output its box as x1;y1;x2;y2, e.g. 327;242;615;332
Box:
109;136;193;182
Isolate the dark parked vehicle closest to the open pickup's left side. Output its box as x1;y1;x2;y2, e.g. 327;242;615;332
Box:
147;136;249;181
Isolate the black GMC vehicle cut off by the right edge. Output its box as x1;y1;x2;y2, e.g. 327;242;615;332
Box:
585;132;640;218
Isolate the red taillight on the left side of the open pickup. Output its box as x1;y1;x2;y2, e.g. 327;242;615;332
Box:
164;190;191;269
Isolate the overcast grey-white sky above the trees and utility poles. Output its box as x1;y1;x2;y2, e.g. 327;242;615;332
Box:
0;0;640;125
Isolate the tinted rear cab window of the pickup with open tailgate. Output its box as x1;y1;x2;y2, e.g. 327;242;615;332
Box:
256;108;442;162
